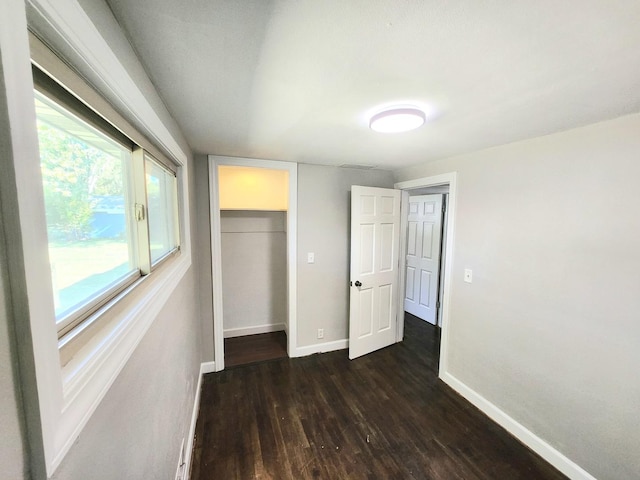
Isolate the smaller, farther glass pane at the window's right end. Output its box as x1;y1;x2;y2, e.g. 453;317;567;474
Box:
145;157;178;265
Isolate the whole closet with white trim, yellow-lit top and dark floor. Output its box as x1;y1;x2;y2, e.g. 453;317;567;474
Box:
209;156;297;370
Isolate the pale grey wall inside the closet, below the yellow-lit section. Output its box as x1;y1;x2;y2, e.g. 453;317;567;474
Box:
220;210;287;337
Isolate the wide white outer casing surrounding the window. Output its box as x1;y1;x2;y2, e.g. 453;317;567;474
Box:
8;0;191;477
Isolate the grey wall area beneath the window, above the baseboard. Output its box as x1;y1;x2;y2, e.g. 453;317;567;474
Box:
52;276;200;480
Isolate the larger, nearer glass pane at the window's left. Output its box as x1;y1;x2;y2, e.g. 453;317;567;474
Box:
35;92;137;321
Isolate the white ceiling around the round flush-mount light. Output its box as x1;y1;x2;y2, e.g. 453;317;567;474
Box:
107;0;640;170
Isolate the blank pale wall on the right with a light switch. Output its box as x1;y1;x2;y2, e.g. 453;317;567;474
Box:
396;115;640;479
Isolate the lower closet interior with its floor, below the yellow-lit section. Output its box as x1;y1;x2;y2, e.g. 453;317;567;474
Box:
220;210;287;367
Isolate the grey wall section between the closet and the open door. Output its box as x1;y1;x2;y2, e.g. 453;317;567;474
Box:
298;164;393;347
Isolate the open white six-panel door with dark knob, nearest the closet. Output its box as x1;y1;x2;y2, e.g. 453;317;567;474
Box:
349;186;401;359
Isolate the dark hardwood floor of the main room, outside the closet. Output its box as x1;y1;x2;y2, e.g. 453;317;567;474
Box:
191;316;565;480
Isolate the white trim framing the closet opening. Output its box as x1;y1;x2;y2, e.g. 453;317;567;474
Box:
208;155;298;372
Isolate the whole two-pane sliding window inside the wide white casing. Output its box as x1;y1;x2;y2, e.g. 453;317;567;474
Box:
34;68;179;337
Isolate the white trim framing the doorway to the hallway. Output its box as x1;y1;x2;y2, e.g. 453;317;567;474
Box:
394;172;457;378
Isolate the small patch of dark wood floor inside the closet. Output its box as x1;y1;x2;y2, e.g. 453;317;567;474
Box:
224;332;287;368
